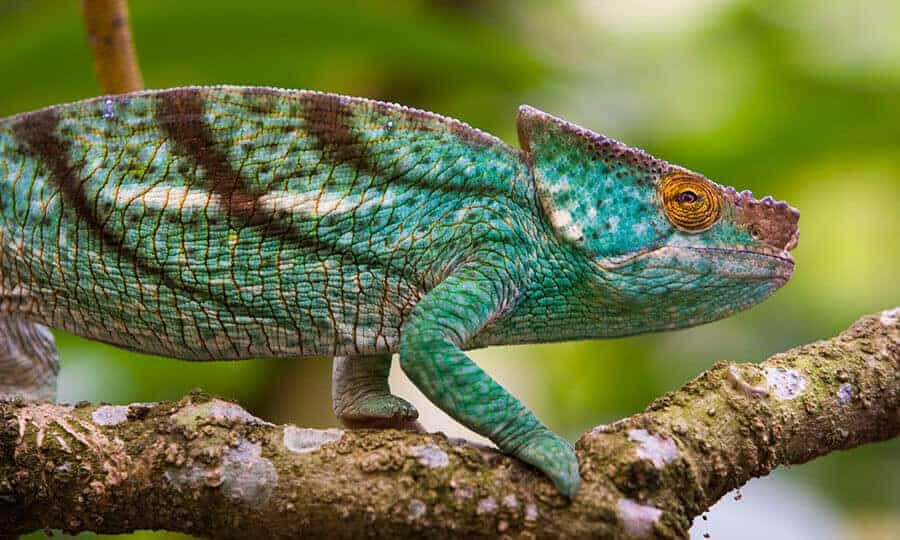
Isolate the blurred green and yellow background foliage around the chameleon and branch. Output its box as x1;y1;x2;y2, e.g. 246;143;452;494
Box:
0;0;900;540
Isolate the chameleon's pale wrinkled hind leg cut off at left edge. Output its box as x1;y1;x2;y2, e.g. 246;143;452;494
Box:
0;315;59;401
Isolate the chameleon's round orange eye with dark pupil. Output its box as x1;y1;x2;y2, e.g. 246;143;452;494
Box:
659;173;722;233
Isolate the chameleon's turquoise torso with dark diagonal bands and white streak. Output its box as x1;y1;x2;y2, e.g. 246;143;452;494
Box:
0;88;528;359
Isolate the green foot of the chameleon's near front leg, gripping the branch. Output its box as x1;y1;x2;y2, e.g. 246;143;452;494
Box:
513;431;581;499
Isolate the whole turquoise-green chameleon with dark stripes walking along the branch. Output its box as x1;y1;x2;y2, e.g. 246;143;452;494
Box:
0;86;799;498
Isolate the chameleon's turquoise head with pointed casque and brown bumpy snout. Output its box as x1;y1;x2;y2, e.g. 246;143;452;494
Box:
519;106;800;335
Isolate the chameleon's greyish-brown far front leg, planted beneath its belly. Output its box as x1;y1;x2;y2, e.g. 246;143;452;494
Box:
331;354;419;428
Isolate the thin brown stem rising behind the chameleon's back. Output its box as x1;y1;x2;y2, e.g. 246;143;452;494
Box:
81;0;144;94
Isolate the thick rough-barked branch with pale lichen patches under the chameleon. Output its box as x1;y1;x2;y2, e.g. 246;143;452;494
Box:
0;308;900;538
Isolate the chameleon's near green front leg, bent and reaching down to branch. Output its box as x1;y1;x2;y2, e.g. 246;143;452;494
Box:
400;266;581;498
